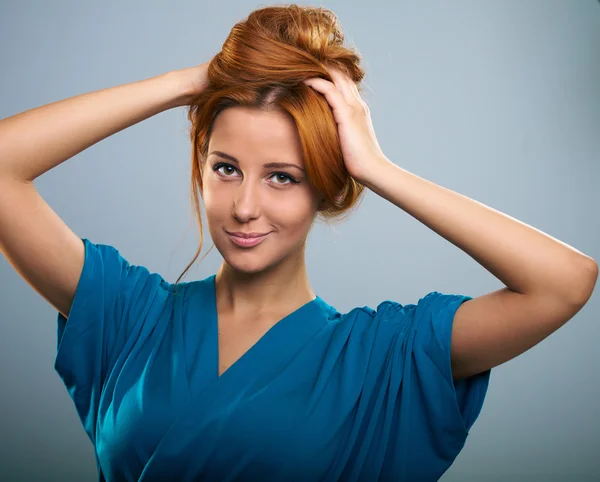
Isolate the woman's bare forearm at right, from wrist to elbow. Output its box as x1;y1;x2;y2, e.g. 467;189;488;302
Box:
363;160;598;302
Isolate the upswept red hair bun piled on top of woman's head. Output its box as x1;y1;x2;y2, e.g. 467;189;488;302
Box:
208;4;365;88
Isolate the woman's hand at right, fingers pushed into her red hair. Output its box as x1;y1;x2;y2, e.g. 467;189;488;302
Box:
304;67;390;184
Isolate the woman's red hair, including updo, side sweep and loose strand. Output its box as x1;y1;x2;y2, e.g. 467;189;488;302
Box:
175;5;365;285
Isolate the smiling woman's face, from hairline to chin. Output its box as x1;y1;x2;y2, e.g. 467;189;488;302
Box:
202;107;318;273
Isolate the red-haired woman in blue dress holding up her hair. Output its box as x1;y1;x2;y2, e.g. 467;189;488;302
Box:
0;5;598;481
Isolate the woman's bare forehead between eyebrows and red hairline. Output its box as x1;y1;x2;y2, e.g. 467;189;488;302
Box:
209;106;302;162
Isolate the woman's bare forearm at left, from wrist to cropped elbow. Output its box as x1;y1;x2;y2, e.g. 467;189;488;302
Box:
0;68;190;181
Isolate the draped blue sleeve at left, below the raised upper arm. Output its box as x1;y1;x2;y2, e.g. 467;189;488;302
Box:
54;238;169;443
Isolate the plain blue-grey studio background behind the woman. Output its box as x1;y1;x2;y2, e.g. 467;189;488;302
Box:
0;0;600;481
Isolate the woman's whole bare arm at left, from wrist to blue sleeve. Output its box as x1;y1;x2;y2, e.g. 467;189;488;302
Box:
0;68;198;317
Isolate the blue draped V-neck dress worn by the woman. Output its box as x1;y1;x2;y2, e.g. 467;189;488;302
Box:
55;238;491;482
